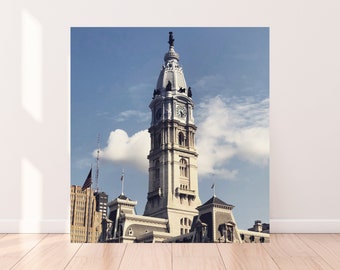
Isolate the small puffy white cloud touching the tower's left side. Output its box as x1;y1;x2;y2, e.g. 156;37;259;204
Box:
93;129;150;172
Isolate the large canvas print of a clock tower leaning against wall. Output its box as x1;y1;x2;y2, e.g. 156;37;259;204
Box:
70;27;270;243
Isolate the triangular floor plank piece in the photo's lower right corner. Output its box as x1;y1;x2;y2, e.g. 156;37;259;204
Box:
298;234;340;269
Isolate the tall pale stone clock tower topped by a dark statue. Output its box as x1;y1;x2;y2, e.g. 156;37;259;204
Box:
144;32;201;235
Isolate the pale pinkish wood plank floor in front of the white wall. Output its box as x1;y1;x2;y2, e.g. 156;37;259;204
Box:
0;234;340;270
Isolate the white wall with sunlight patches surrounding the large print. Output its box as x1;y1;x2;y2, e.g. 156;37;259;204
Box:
0;0;340;233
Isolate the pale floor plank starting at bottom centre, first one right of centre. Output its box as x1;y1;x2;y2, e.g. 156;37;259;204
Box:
172;243;226;270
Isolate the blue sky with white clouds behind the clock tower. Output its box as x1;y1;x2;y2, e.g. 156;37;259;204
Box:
71;27;269;229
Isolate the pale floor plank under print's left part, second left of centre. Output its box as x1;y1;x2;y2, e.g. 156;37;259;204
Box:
65;243;126;270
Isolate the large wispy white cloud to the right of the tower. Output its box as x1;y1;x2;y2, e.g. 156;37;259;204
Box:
196;96;269;179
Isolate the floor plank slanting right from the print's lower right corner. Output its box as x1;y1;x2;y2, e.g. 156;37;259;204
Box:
264;234;333;270
